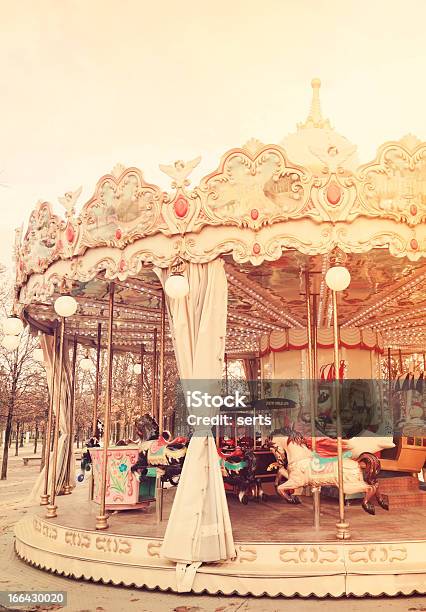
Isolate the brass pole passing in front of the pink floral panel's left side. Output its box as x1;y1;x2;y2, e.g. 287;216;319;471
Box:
96;283;114;529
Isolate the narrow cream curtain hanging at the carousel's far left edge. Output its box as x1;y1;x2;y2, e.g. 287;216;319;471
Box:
27;334;75;503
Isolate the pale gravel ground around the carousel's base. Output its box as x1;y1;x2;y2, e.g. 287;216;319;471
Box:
0;447;426;612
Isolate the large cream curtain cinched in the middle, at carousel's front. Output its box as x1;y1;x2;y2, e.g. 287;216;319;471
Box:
156;259;235;591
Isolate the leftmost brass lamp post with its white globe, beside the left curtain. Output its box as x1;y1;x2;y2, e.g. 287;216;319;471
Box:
46;295;78;518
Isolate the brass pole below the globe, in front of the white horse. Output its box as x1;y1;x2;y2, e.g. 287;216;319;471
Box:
331;290;350;540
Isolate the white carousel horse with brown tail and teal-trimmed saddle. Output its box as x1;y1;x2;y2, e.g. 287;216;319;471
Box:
272;429;389;514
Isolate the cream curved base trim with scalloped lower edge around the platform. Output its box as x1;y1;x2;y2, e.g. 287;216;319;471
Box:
15;516;426;597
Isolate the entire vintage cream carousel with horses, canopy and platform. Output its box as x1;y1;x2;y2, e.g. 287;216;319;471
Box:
10;79;426;597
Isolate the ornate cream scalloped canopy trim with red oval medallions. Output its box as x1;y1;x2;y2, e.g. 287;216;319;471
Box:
15;137;426;298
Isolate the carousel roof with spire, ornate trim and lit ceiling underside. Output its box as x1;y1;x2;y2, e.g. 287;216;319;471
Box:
15;79;426;354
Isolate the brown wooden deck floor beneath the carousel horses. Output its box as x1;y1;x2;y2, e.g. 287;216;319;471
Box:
45;486;426;542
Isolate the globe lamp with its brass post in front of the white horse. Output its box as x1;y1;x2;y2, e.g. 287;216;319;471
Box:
325;265;351;540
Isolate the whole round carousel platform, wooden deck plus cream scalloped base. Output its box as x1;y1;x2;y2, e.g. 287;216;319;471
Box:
15;487;426;597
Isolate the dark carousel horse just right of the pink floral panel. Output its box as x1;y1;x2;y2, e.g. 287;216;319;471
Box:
132;414;189;486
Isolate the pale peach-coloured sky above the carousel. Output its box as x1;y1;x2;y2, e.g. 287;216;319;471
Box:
0;0;426;265
